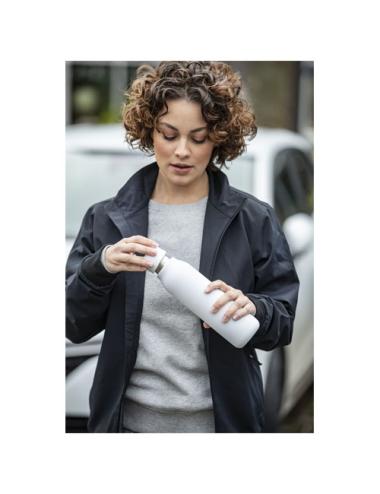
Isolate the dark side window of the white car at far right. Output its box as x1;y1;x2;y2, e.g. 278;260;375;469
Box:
274;149;314;223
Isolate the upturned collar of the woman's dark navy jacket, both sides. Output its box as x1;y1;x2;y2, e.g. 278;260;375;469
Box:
106;162;245;278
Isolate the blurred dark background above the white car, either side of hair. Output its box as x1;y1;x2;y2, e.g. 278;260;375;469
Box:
66;60;314;139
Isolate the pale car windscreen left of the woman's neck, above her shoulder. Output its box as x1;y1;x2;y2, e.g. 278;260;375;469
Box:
66;150;154;237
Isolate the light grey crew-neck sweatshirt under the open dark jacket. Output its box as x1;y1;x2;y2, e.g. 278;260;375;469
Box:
123;197;215;432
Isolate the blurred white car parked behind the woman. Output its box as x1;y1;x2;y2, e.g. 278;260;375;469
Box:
66;124;314;432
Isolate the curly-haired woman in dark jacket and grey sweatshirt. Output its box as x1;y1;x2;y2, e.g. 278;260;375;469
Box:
67;62;298;432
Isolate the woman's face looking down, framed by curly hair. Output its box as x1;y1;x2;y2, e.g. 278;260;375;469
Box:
153;99;214;188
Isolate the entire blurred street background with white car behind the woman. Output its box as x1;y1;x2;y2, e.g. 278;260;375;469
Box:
66;60;314;432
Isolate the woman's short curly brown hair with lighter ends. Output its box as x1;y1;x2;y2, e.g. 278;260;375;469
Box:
122;61;257;170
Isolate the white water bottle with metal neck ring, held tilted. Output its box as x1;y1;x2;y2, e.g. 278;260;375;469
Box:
145;247;260;348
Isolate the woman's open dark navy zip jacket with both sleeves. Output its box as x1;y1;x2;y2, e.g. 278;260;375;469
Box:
66;163;299;432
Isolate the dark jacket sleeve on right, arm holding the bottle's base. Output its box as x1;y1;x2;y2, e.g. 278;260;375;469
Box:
246;206;299;350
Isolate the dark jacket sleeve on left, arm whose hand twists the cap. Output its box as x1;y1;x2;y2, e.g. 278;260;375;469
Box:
66;207;117;343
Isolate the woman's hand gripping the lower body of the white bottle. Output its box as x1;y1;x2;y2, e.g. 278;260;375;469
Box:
203;280;256;328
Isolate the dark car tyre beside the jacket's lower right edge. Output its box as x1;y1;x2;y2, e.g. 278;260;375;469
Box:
264;348;285;432
